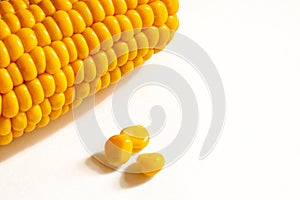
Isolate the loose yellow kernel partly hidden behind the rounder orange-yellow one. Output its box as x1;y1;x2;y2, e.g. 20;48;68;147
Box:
120;125;150;152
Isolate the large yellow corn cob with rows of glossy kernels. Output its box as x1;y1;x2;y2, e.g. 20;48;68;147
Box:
0;0;179;145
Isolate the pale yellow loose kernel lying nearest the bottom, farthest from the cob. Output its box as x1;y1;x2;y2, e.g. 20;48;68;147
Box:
137;153;165;176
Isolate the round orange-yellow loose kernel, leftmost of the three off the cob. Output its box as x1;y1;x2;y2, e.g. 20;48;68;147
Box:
105;135;133;167
